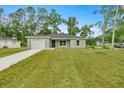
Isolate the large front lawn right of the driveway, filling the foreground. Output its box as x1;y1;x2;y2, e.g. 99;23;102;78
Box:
0;49;124;88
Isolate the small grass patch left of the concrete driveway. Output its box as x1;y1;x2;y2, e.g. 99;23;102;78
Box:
0;48;26;58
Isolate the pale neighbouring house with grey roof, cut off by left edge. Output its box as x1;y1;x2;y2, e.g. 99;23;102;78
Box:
0;37;21;48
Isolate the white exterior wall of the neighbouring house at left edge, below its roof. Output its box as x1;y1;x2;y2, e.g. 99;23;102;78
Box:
0;40;21;48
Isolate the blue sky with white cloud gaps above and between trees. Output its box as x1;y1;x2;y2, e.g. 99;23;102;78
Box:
0;5;103;36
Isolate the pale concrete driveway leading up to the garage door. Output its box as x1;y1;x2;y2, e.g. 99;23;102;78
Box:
0;49;42;71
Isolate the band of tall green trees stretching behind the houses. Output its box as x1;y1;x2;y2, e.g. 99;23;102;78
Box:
0;5;124;46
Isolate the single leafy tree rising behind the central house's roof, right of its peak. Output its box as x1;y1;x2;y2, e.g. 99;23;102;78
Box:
65;17;80;35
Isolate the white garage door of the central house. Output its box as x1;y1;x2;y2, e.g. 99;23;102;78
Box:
31;39;45;49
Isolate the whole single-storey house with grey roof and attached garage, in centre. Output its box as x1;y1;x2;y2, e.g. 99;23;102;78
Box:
26;34;86;49
